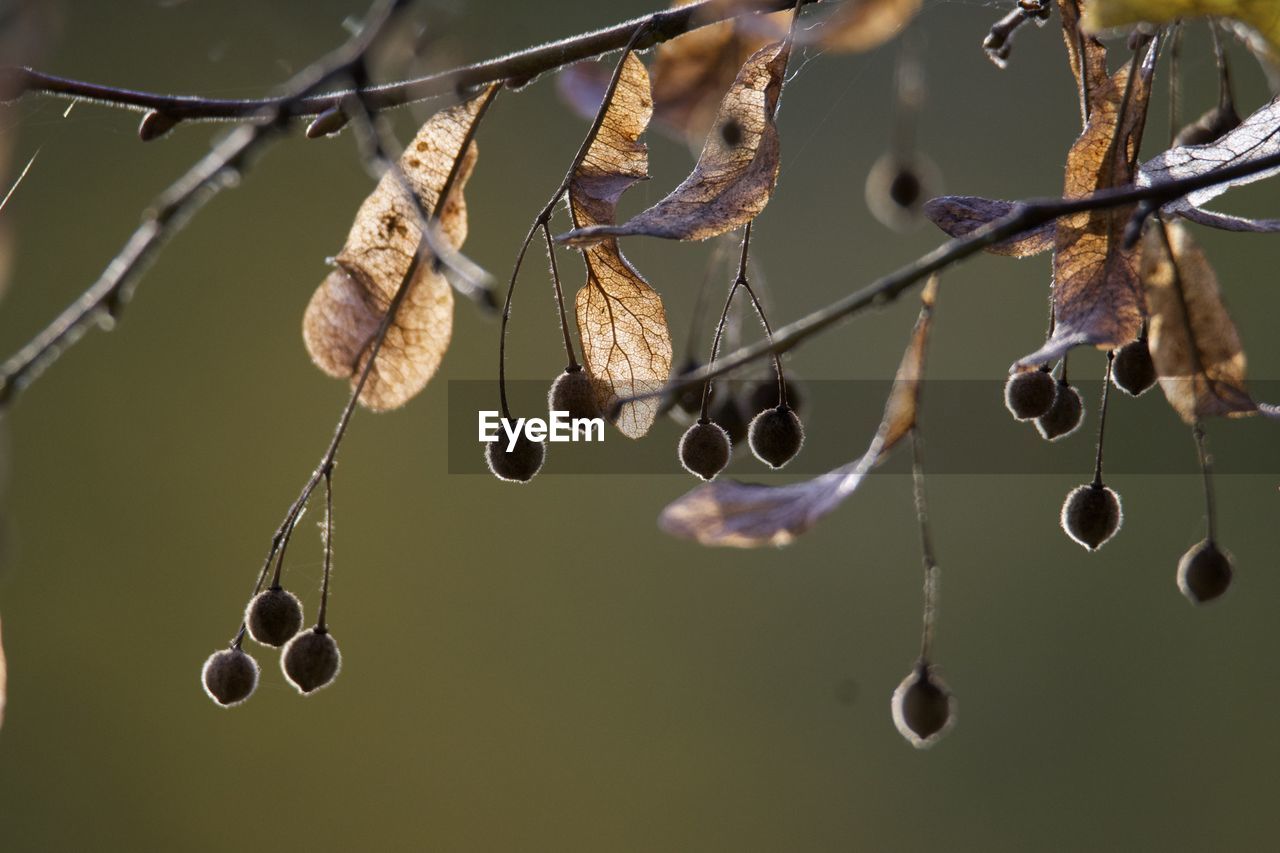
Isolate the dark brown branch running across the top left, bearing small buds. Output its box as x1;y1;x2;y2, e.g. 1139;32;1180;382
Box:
0;0;820;131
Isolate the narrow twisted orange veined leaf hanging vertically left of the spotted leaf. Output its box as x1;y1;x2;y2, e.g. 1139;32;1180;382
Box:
568;54;671;438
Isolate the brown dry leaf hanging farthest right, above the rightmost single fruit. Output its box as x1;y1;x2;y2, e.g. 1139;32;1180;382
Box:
1142;222;1270;424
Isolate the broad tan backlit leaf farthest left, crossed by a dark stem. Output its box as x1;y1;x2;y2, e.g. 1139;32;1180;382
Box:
302;88;493;411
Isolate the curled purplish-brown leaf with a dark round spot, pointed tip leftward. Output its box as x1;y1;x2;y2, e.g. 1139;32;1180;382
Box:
559;41;791;245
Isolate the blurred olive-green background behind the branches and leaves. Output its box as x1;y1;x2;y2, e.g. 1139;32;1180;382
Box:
0;0;1280;850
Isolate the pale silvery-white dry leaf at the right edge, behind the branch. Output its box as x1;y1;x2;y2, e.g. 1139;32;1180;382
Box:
1138;97;1280;232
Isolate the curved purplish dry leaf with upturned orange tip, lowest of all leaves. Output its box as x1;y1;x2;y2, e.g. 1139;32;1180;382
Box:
658;277;938;548
